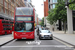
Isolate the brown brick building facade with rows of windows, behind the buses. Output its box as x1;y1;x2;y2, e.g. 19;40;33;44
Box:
0;0;25;20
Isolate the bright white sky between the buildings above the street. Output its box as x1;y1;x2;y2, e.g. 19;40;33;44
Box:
32;0;44;19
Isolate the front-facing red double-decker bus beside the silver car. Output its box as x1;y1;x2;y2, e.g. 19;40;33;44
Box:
12;7;35;39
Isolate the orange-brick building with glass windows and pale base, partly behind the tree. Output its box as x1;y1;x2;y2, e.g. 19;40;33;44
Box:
44;0;58;30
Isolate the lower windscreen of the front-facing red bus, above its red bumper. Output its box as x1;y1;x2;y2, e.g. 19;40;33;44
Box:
15;22;34;32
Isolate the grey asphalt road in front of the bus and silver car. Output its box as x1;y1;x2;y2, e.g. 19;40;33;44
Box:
0;29;73;50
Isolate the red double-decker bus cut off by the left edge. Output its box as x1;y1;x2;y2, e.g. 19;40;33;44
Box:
0;19;13;35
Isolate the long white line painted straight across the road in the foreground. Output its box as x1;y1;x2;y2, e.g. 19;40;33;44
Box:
1;45;67;48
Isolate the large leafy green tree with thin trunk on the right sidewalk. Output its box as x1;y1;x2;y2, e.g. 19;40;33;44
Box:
47;0;67;33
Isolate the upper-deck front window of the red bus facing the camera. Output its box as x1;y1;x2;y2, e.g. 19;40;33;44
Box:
16;8;33;15
